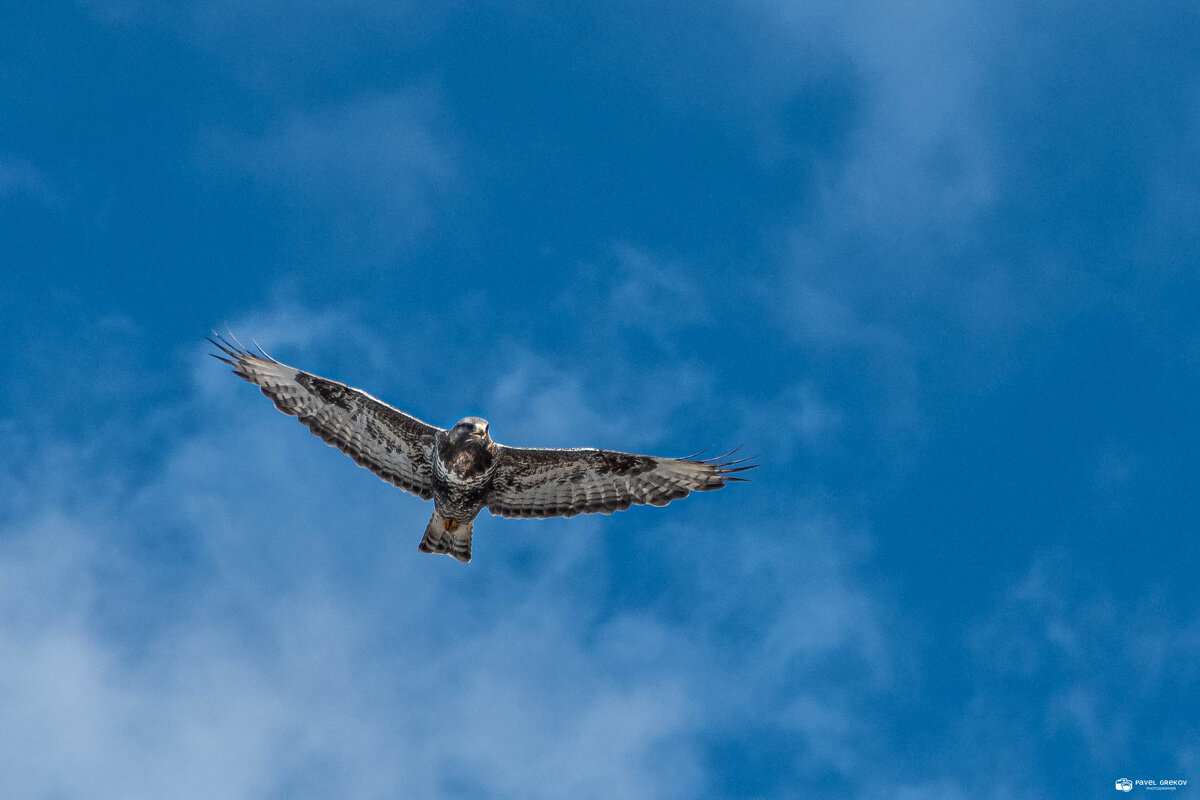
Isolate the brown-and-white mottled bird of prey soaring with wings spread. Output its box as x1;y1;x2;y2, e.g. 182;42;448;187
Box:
209;333;756;564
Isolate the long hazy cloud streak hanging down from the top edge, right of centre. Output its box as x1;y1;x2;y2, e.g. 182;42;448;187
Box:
748;2;1012;450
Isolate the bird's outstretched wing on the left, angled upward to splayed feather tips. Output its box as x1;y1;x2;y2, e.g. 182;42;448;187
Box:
209;337;440;500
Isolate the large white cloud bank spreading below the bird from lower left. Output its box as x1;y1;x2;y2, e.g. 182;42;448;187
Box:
0;303;890;798
